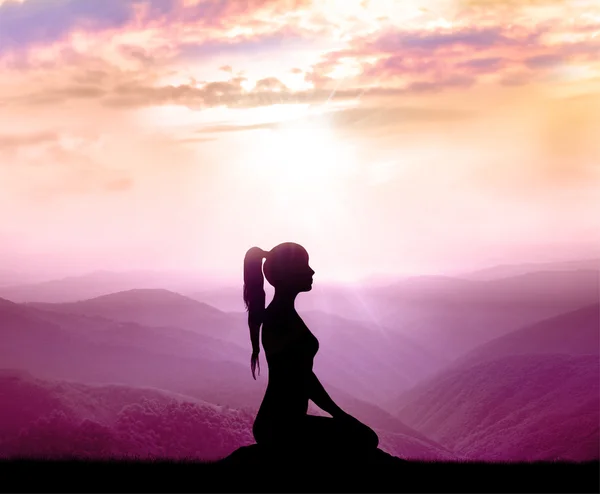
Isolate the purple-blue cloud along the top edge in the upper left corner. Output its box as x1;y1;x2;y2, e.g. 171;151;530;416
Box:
0;0;311;54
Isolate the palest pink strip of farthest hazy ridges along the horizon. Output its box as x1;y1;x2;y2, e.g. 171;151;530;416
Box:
0;259;600;310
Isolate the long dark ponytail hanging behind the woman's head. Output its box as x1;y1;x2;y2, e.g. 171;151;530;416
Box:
244;247;267;379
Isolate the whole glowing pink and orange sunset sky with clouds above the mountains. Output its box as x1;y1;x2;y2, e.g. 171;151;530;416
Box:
0;0;600;280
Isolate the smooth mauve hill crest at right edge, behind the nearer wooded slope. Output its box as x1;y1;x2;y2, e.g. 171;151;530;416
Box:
457;304;600;365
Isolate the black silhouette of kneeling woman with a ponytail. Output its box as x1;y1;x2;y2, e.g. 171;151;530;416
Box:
244;242;379;451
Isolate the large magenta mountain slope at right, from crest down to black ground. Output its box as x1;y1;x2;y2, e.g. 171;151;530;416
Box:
386;303;600;461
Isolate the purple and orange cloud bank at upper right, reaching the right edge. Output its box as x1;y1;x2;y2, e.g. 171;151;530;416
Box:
306;10;600;90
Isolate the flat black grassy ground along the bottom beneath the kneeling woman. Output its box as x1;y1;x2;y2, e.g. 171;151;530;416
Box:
0;445;600;493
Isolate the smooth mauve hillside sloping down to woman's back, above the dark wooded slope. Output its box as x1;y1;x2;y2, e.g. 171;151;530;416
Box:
0;302;264;406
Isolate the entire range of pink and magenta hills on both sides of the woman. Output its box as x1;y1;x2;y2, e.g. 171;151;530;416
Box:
0;263;600;461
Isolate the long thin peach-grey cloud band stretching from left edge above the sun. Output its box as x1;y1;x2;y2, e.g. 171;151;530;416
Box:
0;58;508;110
